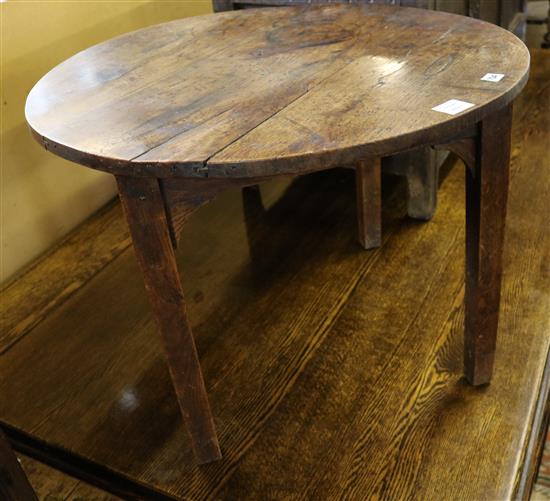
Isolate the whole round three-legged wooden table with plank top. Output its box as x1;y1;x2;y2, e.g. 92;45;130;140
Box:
25;5;529;462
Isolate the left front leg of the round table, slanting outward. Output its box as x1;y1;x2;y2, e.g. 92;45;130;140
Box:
117;176;221;463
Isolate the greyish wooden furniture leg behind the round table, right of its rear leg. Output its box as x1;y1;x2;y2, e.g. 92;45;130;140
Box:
406;147;439;220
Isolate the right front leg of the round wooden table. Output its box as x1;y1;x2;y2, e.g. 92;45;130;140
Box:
464;106;512;385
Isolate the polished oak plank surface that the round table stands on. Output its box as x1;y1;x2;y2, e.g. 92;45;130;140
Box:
0;36;550;501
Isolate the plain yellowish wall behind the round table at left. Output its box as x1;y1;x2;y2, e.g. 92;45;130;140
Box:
0;0;211;282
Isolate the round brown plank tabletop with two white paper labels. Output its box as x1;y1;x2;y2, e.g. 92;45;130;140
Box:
25;5;529;177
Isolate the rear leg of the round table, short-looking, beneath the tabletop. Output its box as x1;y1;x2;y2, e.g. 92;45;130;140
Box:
355;158;382;249
